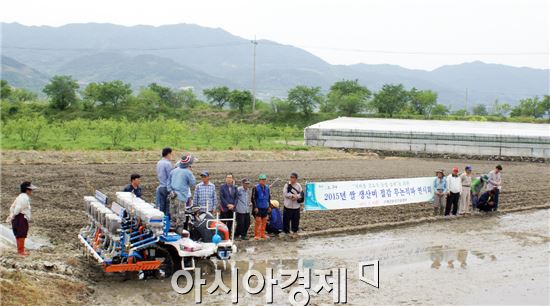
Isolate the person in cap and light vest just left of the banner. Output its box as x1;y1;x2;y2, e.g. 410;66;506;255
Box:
283;172;303;236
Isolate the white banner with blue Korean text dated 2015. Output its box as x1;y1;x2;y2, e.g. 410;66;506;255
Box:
304;177;434;210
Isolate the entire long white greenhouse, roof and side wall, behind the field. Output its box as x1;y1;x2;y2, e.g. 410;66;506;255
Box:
304;117;550;158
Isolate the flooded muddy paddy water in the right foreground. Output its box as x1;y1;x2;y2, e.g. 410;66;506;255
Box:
93;210;550;305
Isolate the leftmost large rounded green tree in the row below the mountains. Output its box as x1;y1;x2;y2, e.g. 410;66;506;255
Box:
42;75;79;110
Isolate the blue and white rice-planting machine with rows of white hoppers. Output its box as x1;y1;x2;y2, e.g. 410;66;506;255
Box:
78;191;237;277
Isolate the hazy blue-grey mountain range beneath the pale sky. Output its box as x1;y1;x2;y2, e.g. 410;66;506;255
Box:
0;23;550;109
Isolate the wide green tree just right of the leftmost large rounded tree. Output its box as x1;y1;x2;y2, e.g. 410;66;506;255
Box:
84;80;132;110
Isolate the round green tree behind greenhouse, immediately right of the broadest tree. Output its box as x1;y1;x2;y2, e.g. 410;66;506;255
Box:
371;84;409;118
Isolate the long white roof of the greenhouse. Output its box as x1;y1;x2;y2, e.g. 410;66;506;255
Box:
307;117;550;138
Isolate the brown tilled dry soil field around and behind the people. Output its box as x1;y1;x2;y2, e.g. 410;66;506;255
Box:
0;152;550;301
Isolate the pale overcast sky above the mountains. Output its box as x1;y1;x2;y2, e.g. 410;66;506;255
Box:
0;0;550;70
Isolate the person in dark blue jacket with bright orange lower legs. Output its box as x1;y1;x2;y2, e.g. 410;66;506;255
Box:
251;174;271;240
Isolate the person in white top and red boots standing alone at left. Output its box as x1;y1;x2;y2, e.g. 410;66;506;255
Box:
6;182;36;256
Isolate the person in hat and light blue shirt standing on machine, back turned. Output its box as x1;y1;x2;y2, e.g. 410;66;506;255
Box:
166;155;196;226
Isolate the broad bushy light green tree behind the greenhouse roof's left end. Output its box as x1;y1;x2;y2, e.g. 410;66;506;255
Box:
330;79;371;116
